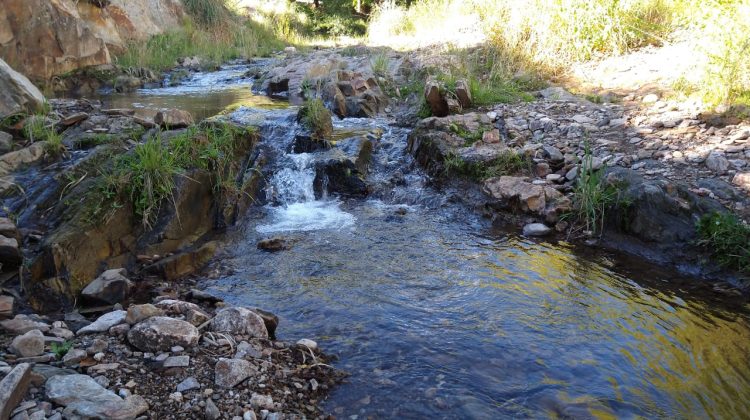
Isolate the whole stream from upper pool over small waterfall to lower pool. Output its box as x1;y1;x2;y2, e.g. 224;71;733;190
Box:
105;64;750;418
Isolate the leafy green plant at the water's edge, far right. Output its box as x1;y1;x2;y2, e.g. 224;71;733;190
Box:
696;212;750;273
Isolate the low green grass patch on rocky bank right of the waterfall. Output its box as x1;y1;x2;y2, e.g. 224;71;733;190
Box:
443;150;530;181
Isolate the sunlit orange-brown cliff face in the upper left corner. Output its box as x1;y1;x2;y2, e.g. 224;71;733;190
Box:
0;0;185;82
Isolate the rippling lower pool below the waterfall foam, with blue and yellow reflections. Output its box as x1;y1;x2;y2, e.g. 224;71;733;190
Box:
203;201;750;418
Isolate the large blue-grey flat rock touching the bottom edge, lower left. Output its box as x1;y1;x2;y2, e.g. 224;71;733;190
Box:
45;375;148;419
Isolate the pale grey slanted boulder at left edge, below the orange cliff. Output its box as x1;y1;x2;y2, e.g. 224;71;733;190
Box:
0;58;45;119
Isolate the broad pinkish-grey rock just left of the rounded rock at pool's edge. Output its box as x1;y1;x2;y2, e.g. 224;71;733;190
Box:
128;316;200;352
